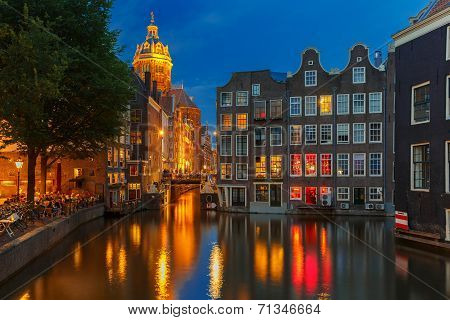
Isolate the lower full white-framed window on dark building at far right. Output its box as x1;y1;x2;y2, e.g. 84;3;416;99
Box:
411;144;430;190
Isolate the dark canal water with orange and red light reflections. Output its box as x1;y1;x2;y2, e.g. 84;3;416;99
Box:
0;191;450;299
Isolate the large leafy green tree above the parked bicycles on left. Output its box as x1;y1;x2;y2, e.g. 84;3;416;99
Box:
0;0;133;200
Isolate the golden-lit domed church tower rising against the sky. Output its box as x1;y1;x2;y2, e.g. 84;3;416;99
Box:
133;12;173;94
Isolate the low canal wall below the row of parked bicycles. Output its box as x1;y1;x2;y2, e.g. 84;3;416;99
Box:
0;204;105;283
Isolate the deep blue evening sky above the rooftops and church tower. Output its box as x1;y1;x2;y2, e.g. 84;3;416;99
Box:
112;0;428;125
